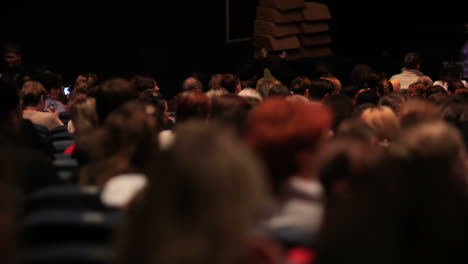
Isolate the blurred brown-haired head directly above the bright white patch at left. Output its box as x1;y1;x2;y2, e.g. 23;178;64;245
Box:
77;100;159;187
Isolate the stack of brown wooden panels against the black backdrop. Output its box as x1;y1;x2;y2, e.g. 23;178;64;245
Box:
253;0;332;59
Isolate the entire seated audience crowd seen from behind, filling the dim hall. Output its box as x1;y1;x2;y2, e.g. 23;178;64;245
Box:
0;45;468;264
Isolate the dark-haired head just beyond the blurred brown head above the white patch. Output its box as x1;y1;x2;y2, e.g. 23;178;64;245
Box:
94;78;135;124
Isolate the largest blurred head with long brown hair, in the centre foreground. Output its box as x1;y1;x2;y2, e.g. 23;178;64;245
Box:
115;121;268;264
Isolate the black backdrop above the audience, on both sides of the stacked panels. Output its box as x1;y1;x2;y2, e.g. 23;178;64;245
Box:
0;0;467;94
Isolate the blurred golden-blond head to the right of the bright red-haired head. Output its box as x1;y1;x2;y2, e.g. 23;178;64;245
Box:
361;106;400;141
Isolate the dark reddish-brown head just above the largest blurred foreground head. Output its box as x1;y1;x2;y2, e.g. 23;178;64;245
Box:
175;91;211;123
